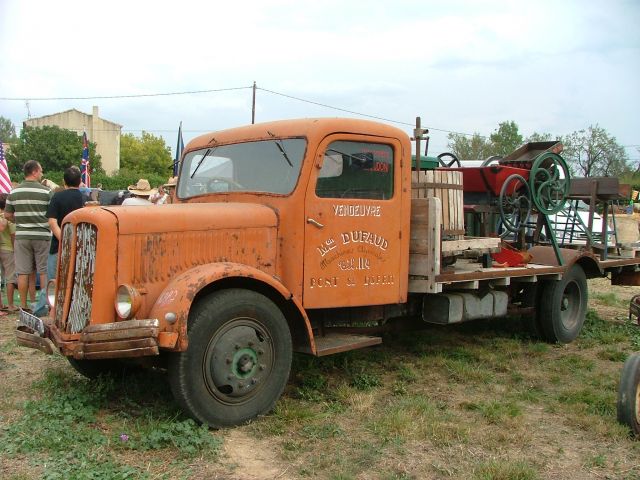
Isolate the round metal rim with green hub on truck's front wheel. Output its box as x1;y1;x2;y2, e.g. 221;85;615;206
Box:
202;317;275;405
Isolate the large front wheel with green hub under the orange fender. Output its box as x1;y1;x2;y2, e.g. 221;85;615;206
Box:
169;289;292;428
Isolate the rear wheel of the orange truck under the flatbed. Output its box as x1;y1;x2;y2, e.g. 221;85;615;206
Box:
538;265;588;343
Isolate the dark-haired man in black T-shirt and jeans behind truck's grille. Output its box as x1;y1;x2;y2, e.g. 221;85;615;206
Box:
33;166;86;317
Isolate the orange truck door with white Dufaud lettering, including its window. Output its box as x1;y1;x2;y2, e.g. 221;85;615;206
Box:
303;135;408;308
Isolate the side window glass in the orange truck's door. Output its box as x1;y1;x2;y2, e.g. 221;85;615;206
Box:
316;140;393;200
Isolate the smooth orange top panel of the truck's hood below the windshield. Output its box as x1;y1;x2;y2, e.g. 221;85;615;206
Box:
106;203;278;235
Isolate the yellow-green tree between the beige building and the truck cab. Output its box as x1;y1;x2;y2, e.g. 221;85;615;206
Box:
120;131;173;177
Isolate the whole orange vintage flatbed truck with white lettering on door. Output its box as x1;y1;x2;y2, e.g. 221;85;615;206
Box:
16;119;640;427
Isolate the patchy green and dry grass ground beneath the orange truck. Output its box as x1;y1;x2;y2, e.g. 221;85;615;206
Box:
0;280;640;480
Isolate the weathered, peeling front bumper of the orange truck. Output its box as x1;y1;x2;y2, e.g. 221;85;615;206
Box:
16;310;164;360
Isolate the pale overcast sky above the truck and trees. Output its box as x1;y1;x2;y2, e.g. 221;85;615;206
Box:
0;0;640;160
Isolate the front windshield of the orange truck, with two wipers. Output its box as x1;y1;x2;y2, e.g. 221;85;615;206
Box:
178;138;307;198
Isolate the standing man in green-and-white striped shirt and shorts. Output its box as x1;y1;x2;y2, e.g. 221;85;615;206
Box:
4;160;51;311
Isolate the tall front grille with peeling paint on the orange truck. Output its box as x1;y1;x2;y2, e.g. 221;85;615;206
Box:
56;223;98;333
